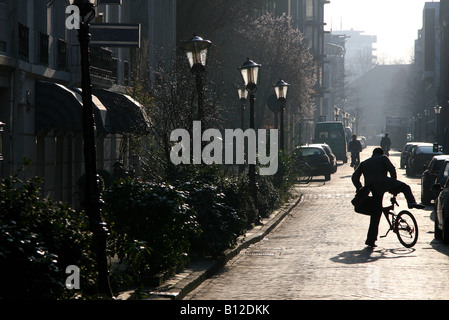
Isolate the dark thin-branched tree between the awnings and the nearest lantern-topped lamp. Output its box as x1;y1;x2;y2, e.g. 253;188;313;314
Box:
130;51;226;180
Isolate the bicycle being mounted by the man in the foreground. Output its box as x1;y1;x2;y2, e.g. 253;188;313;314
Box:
380;195;418;248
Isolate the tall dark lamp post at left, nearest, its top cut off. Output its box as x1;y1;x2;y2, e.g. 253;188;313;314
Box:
70;0;112;297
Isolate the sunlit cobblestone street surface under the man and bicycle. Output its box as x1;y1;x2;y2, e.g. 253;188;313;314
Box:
185;147;449;300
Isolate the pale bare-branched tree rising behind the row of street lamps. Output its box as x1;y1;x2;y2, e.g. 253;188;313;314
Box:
233;13;316;129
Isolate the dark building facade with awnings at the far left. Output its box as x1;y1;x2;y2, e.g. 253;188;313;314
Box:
0;0;176;207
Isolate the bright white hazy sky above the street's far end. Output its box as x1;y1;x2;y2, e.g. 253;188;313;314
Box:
324;0;439;63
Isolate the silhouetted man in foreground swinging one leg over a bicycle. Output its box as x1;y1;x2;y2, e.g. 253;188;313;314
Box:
352;148;425;247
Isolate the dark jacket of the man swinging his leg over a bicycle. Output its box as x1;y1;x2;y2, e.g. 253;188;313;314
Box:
352;155;401;194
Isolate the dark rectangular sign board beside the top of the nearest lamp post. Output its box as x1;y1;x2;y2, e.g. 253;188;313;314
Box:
90;23;140;48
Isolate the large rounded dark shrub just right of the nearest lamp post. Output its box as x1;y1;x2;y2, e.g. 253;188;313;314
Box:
105;178;198;281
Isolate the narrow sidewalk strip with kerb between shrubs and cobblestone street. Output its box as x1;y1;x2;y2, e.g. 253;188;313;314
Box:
117;185;301;300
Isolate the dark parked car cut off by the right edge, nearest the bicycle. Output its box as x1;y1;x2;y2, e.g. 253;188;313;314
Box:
432;168;449;244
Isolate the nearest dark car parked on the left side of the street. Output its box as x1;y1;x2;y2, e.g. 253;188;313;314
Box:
295;145;333;181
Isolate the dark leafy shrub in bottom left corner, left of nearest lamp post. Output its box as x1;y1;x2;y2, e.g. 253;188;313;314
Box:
0;177;95;299
